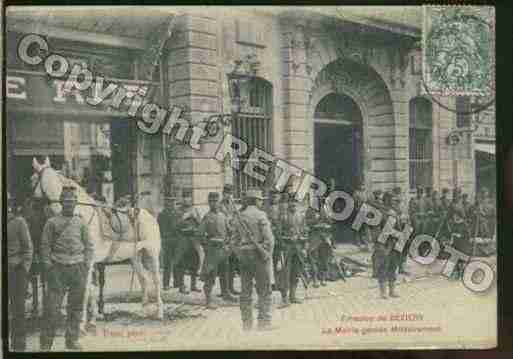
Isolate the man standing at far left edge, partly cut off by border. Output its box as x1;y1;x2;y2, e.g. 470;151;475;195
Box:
7;193;34;352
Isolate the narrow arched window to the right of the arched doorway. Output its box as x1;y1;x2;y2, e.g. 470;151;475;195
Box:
409;97;433;189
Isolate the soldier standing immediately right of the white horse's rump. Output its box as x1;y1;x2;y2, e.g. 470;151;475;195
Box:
157;196;187;294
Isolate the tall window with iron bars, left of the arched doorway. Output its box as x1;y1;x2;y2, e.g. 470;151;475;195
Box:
232;79;272;197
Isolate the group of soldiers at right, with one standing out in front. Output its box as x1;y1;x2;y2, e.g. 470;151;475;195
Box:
355;186;496;299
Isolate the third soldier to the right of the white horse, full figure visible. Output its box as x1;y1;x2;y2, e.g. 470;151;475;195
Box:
200;192;236;309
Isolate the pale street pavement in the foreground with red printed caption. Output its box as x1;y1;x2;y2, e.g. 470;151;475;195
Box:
20;245;497;351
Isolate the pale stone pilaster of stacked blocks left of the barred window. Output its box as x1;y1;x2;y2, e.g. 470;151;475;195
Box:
168;11;223;204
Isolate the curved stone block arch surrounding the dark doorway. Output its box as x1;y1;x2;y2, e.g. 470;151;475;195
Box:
309;59;400;189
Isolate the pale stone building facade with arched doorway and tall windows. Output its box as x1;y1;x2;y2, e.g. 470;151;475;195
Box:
5;8;495;211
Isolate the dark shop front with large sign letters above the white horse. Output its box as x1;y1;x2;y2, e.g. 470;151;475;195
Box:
6;33;160;208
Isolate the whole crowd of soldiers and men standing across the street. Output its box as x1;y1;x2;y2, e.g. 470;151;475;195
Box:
7;184;496;351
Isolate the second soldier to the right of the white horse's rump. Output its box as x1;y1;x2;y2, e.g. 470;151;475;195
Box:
180;188;205;294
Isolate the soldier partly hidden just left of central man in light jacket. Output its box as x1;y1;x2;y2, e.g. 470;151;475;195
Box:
219;184;240;298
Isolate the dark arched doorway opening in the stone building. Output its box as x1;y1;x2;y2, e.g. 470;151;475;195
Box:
314;93;363;193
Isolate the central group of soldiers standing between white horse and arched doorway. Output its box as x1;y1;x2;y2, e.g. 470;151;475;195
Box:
158;185;332;330
